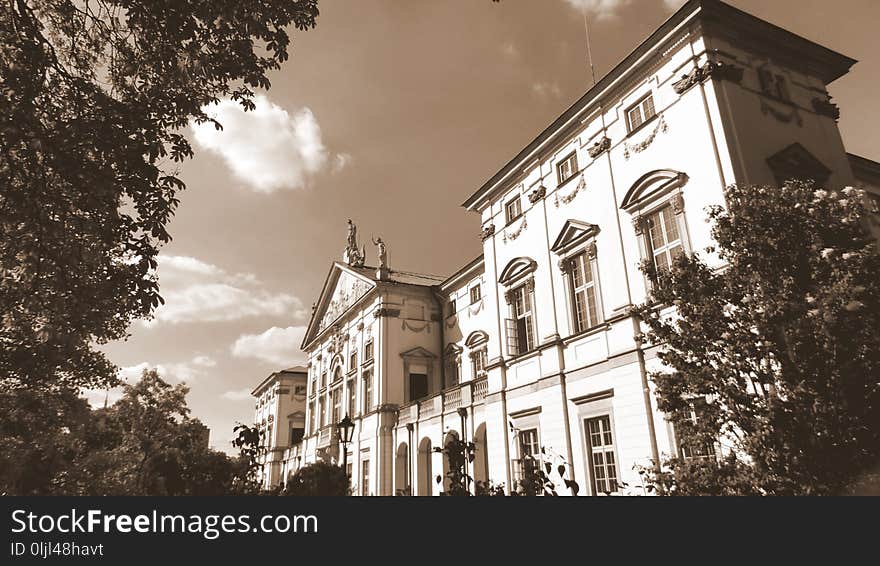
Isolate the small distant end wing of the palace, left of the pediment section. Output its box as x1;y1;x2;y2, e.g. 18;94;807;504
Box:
251;366;308;489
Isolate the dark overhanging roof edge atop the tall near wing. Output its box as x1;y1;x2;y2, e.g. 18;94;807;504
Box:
462;0;856;210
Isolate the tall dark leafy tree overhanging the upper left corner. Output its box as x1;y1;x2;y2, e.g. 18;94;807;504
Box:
0;0;318;387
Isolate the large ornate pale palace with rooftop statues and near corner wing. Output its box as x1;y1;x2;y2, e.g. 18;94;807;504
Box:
253;0;880;495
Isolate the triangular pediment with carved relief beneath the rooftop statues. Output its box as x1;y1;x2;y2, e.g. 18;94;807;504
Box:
302;262;376;349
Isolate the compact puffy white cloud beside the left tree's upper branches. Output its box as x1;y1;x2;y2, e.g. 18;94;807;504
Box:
190;94;329;193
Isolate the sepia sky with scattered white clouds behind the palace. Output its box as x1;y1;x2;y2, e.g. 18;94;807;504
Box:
89;0;880;451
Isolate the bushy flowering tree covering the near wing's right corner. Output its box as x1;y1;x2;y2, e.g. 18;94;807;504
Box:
637;181;880;495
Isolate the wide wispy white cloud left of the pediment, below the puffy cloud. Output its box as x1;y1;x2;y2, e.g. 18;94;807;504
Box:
143;254;307;327
